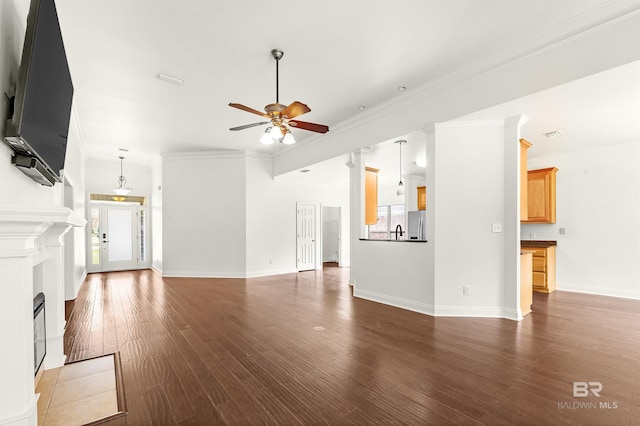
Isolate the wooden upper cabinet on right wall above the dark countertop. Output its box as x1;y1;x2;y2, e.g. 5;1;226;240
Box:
523;167;558;223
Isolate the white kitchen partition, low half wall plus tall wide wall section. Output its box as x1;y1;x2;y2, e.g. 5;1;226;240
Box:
351;120;519;319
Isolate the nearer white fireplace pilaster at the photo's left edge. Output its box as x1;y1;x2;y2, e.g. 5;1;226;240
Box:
0;223;48;425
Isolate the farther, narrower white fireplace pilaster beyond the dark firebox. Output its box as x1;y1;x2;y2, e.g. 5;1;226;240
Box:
42;224;71;370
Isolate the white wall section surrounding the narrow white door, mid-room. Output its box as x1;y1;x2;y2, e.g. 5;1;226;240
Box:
247;156;350;276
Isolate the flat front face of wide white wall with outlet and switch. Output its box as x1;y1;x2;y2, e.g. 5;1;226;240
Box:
427;122;505;316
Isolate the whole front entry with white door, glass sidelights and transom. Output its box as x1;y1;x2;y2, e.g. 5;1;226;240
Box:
87;194;151;272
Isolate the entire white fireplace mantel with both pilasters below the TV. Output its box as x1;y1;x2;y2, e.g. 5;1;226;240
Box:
0;206;86;425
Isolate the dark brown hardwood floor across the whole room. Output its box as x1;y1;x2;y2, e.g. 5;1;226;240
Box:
65;268;640;425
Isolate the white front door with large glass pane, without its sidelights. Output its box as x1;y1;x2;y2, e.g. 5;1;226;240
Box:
100;206;138;272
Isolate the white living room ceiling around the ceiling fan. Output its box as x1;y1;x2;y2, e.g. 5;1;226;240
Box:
56;0;639;168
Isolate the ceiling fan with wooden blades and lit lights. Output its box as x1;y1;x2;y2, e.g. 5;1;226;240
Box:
229;49;329;144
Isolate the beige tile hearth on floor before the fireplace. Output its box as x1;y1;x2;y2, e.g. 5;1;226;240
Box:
36;355;118;426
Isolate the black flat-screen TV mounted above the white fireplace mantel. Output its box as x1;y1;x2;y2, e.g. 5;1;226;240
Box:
4;0;73;186
